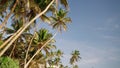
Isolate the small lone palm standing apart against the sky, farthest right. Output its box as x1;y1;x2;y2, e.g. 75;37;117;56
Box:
70;50;81;65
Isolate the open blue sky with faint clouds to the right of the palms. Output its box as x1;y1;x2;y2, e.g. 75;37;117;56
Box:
56;0;120;68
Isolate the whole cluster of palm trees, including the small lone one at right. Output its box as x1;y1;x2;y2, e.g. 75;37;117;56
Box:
0;0;81;68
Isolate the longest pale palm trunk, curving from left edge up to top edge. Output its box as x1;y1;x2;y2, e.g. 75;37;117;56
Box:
0;0;54;56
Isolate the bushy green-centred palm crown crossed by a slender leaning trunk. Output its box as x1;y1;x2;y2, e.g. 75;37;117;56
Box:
33;28;56;54
